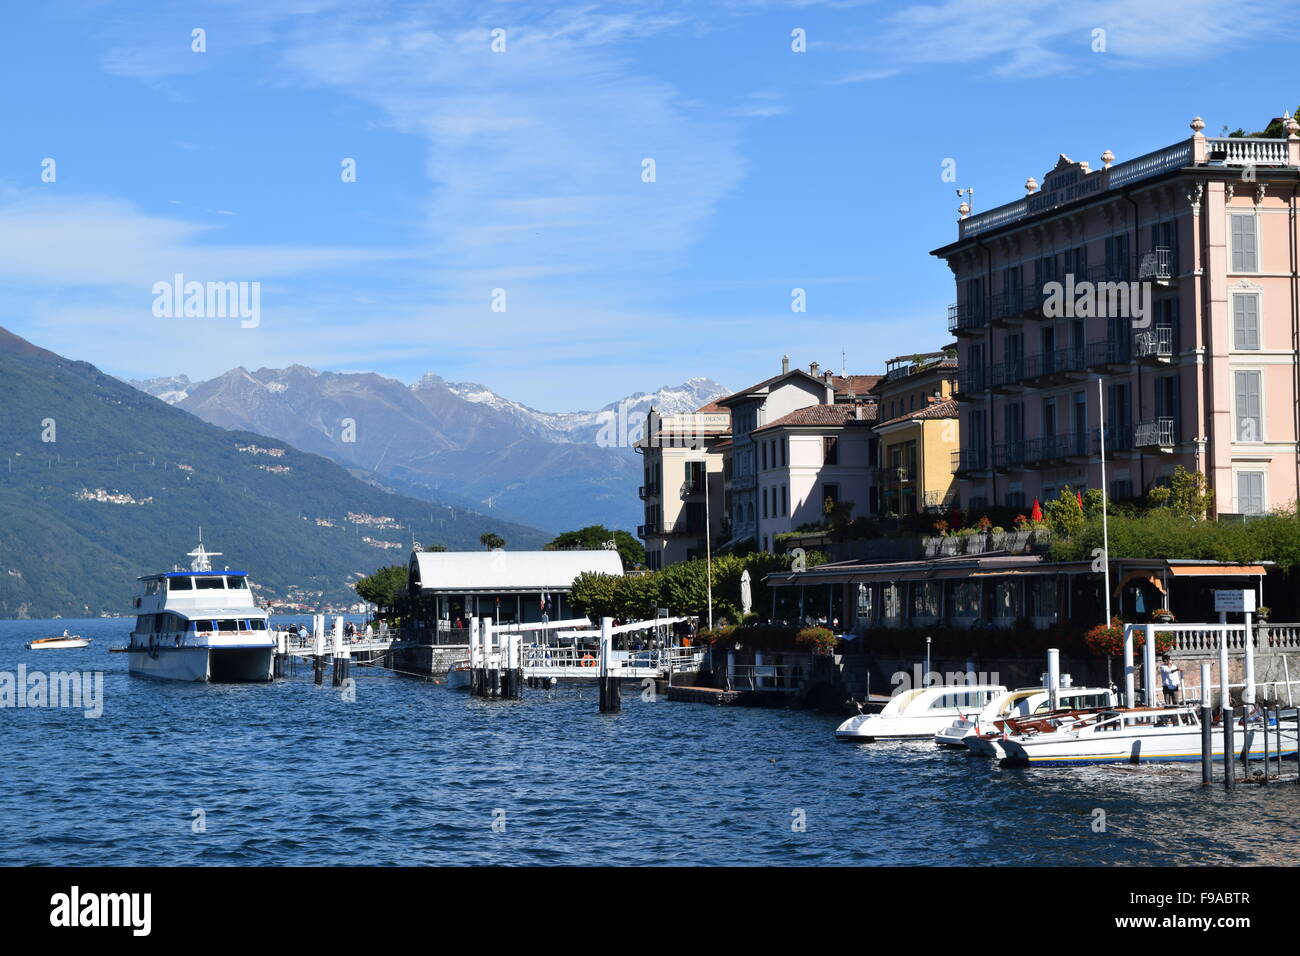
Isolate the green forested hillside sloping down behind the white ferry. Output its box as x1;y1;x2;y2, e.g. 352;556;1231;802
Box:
0;328;547;618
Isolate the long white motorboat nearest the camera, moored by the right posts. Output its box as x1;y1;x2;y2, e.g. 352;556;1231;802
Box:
966;704;1296;766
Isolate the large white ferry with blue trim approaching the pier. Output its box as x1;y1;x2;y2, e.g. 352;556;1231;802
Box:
126;538;276;682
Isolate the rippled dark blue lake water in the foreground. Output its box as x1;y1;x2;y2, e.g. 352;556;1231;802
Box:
0;620;1300;865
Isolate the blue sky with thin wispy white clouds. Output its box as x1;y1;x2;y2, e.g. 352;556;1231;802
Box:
0;0;1300;410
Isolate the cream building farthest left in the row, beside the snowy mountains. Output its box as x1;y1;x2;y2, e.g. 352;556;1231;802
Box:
633;405;731;571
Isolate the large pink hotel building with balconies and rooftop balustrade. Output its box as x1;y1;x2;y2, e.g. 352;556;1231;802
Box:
933;117;1300;514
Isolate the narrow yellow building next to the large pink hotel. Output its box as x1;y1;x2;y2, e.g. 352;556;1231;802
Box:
872;349;959;515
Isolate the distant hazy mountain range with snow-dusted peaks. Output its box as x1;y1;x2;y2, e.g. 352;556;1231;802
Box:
130;365;727;533
